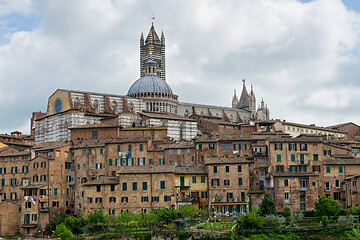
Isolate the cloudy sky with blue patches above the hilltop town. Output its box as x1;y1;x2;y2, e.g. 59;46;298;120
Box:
0;0;360;133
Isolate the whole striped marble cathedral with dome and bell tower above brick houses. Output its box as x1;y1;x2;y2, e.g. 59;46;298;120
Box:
32;24;269;143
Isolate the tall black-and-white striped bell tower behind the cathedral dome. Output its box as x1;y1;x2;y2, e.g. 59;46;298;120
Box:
140;23;166;81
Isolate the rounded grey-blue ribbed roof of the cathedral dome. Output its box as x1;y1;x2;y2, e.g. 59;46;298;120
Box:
127;75;173;95
